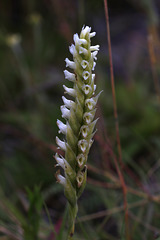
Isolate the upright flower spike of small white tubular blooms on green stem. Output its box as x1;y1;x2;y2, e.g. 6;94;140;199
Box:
55;26;100;239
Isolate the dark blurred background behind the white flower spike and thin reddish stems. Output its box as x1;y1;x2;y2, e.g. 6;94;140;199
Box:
0;0;160;240
